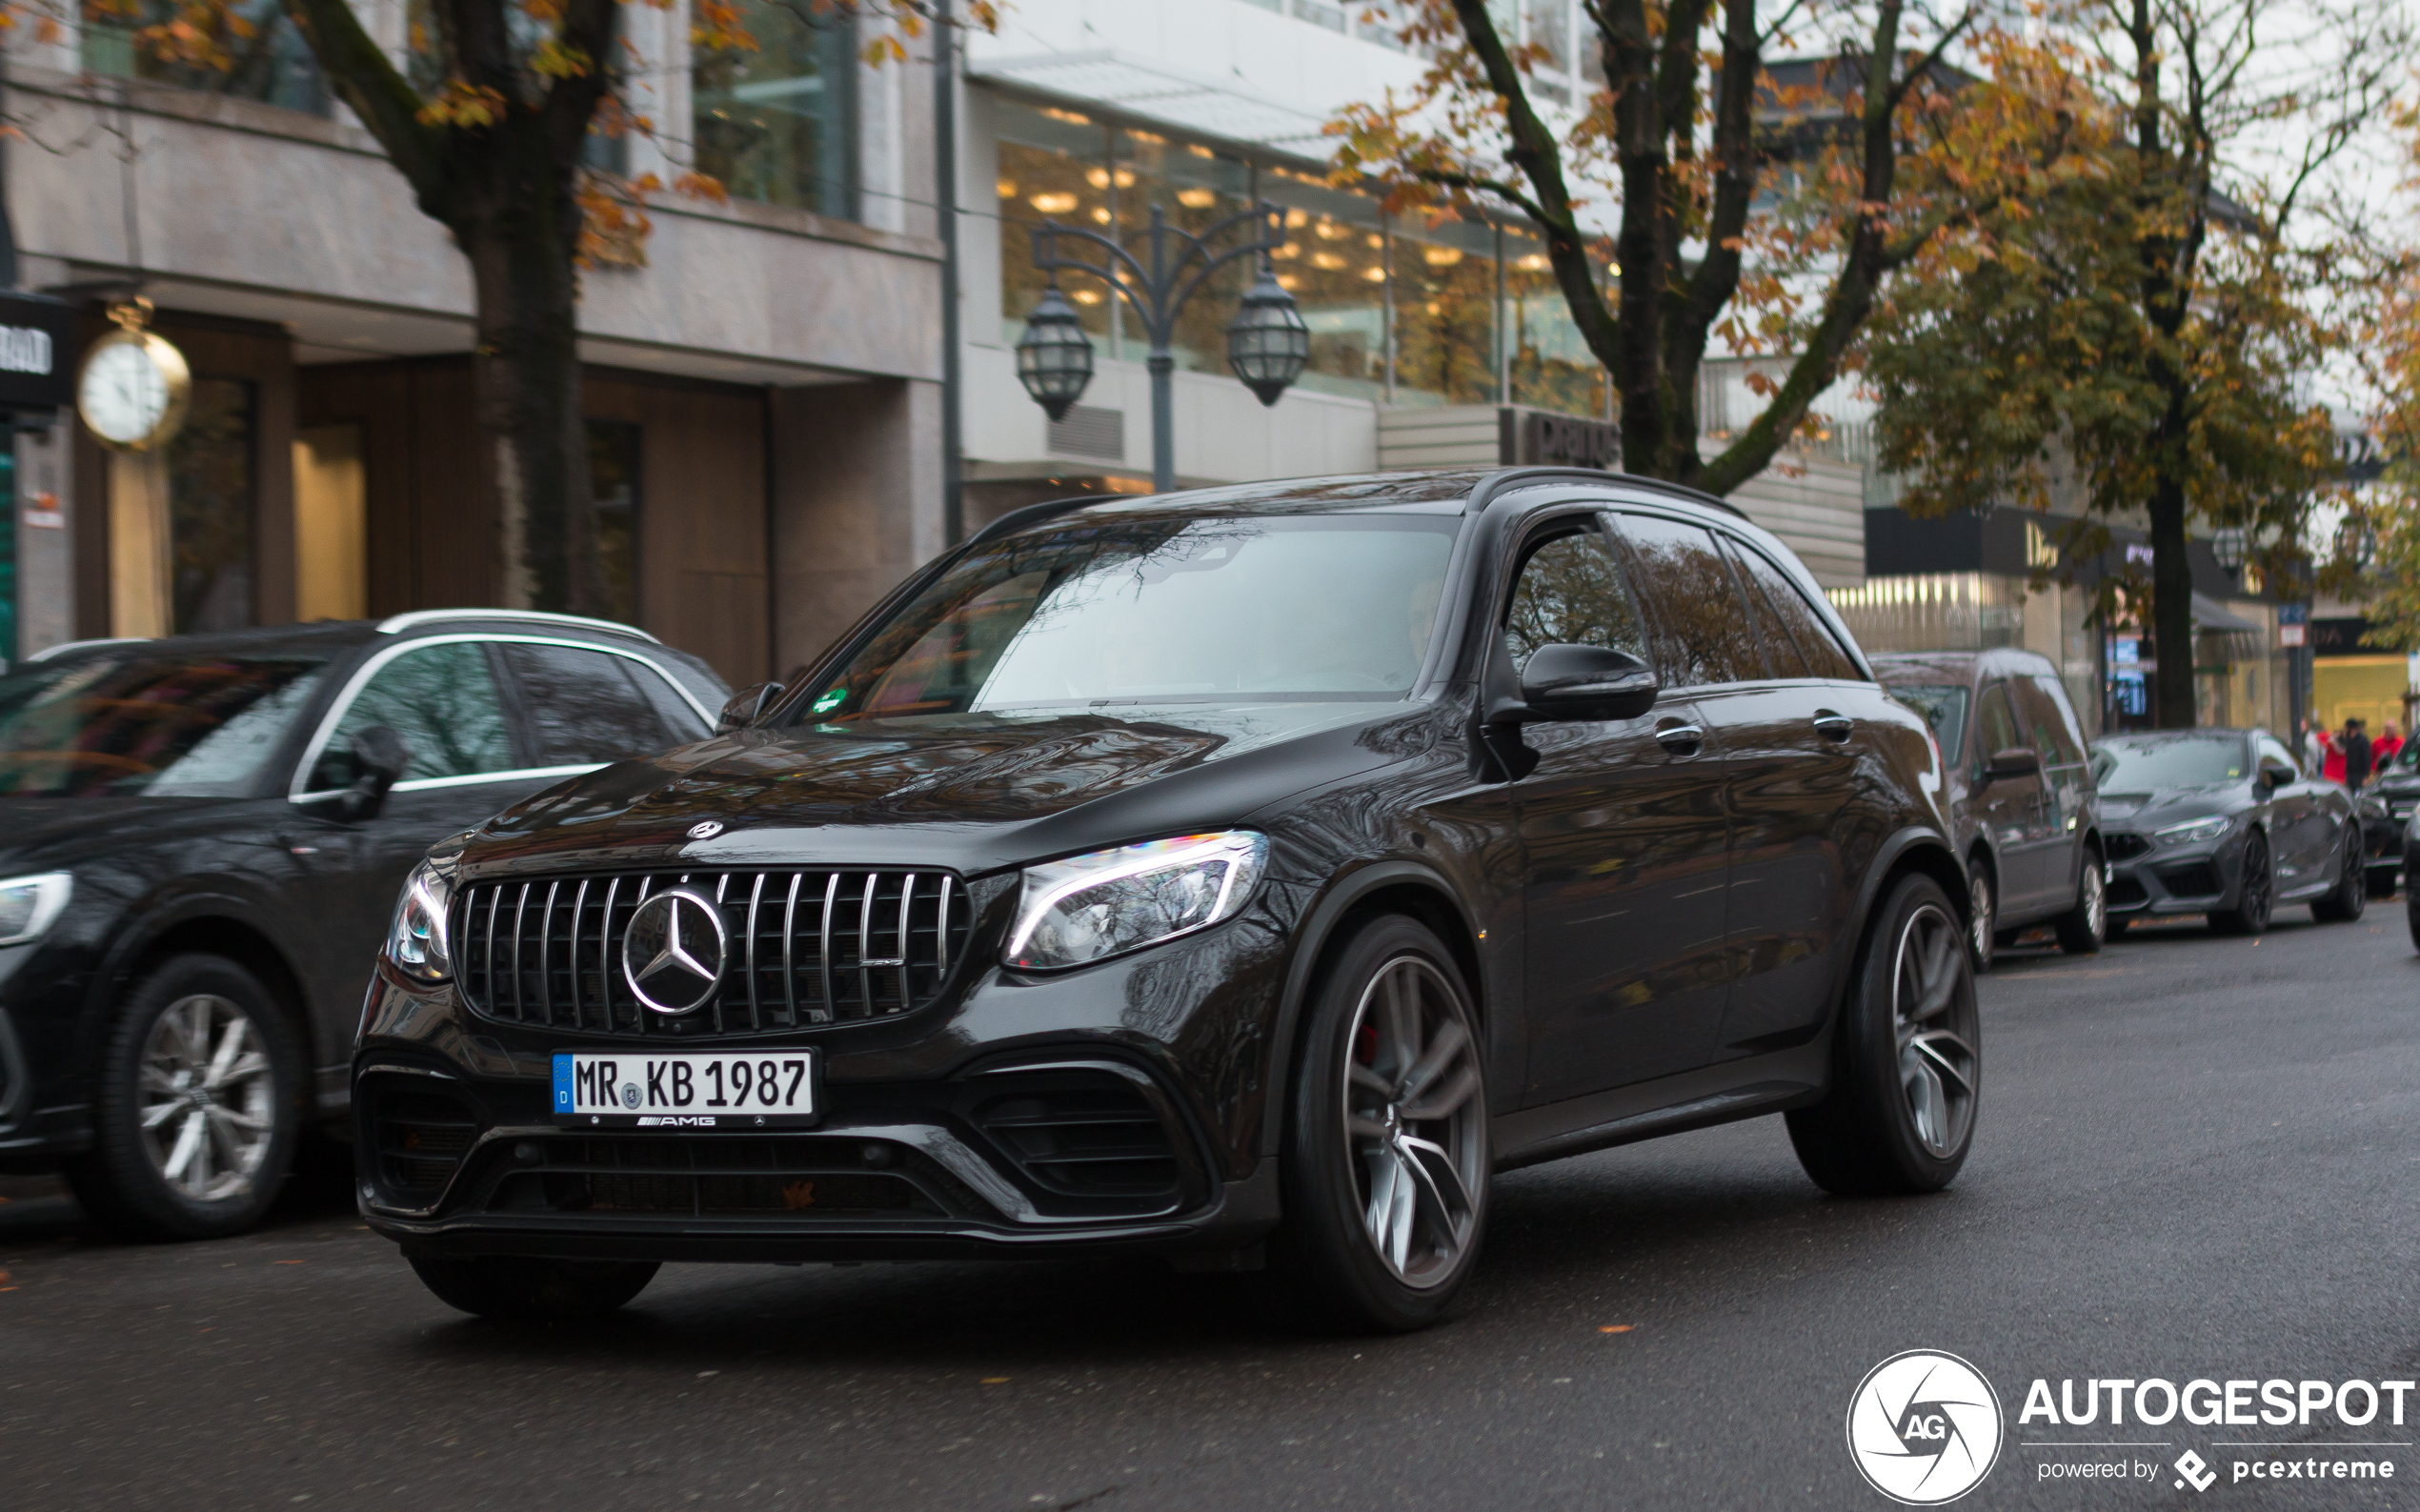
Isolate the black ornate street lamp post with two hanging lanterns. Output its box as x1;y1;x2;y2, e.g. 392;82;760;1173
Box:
1017;201;1312;494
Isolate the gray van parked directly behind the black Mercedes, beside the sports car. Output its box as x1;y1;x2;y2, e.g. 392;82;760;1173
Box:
1868;651;2107;970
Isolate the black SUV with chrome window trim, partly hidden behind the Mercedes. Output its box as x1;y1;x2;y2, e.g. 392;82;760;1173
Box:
0;610;726;1237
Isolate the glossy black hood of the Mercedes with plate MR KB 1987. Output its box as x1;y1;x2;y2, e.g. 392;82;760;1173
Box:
465;704;1435;874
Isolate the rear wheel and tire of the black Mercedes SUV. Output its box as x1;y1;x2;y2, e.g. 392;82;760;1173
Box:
1786;874;1982;1198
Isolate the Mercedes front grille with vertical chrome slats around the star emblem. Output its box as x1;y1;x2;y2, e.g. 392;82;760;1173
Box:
453;869;971;1040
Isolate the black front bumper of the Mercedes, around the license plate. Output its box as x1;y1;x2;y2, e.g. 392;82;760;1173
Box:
353;895;1282;1260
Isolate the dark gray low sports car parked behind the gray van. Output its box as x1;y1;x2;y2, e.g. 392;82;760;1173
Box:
2093;731;2370;934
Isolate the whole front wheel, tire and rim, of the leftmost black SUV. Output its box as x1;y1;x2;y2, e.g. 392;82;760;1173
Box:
68;956;305;1239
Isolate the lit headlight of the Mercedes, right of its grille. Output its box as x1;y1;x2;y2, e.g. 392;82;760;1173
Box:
1004;830;1268;970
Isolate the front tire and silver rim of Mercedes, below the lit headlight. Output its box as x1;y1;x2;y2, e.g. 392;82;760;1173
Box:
1282;915;1491;1333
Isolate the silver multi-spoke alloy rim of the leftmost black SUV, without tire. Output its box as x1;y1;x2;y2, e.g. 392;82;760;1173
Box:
138;995;276;1202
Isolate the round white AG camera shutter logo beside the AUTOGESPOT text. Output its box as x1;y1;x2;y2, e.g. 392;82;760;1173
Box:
1849;1350;2002;1507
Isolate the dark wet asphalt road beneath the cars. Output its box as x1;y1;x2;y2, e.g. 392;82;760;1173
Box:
0;902;2420;1512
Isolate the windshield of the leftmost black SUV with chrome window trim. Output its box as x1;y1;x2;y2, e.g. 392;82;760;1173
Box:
0;651;324;798
